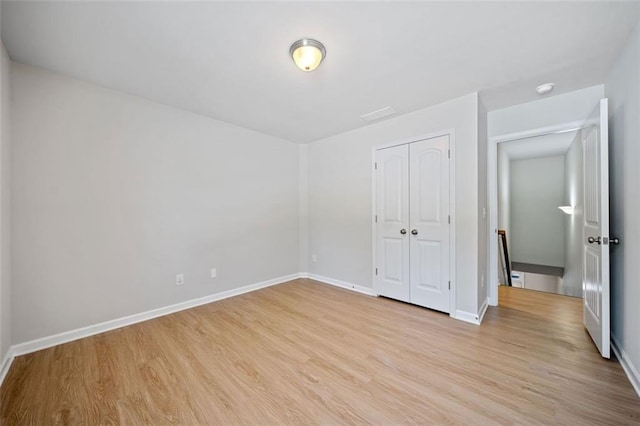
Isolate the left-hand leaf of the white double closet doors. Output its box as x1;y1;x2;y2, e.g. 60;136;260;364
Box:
375;145;410;302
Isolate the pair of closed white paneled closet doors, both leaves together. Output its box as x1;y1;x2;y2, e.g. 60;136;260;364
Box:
375;136;450;312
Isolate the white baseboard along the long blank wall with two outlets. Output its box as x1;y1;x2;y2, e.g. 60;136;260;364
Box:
10;273;300;357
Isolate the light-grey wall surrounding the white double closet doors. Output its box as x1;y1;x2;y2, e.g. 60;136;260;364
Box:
309;94;479;314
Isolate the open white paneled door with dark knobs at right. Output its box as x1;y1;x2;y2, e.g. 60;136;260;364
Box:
582;99;610;358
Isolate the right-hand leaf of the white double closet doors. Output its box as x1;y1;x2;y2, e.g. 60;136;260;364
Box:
409;136;450;312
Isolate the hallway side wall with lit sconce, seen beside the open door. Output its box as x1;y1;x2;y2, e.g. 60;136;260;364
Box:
560;131;584;297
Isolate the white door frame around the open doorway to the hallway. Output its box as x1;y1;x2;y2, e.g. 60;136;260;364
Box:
487;120;585;306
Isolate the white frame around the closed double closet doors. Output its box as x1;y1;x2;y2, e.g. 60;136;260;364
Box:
371;129;457;318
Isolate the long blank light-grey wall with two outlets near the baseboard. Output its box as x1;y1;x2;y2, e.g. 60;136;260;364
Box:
11;64;299;344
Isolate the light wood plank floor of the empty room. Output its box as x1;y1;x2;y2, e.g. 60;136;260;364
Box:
0;280;640;425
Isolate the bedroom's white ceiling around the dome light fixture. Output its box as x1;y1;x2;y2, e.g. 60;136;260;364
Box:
1;1;638;143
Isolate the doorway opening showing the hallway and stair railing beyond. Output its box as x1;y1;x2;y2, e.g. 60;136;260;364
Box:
497;130;583;297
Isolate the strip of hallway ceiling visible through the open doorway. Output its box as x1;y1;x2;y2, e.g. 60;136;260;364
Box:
498;130;577;161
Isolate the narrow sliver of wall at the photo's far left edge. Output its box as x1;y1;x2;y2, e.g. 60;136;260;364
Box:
0;42;12;367
